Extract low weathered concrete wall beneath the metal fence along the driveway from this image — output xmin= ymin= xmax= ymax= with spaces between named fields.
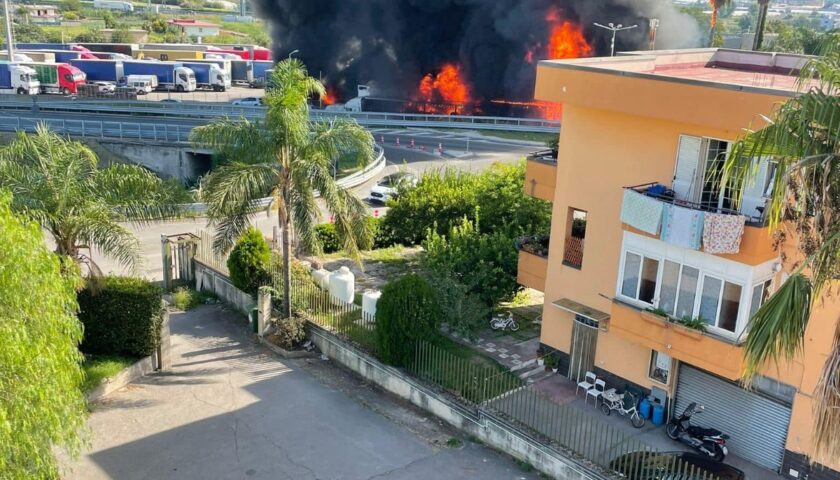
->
xmin=307 ymin=324 xmax=609 ymax=480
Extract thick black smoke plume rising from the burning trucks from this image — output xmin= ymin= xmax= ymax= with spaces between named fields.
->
xmin=251 ymin=0 xmax=701 ymax=101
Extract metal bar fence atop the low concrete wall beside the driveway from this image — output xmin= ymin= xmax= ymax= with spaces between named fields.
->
xmin=284 ymin=274 xmax=717 ymax=480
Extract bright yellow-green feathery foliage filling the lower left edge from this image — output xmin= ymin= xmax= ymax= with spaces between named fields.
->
xmin=0 ymin=191 xmax=87 ymax=479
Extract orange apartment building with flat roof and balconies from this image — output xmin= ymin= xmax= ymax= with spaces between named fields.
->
xmin=519 ymin=49 xmax=840 ymax=479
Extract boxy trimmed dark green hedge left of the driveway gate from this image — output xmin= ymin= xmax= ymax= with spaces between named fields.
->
xmin=78 ymin=277 xmax=163 ymax=357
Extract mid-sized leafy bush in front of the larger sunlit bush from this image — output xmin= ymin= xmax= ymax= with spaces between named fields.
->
xmin=423 ymin=218 xmax=519 ymax=307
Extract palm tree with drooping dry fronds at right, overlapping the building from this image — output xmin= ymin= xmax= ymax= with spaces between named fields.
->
xmin=724 ymin=32 xmax=840 ymax=460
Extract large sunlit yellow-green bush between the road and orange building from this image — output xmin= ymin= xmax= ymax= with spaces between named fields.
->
xmin=380 ymin=161 xmax=551 ymax=246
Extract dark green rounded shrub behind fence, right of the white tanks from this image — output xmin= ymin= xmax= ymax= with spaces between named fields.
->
xmin=376 ymin=274 xmax=442 ymax=366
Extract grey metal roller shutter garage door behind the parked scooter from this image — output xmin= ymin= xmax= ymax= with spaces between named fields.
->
xmin=674 ymin=364 xmax=790 ymax=471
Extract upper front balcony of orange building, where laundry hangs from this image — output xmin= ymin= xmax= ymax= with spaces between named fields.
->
xmin=622 ymin=182 xmax=779 ymax=265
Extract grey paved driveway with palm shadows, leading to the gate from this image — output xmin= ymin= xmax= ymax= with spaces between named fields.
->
xmin=64 ymin=306 xmax=537 ymax=480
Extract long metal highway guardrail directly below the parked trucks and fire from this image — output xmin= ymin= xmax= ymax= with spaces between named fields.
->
xmin=0 ymin=98 xmax=560 ymax=133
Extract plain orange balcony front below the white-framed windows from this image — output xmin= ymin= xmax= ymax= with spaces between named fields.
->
xmin=609 ymin=300 xmax=743 ymax=380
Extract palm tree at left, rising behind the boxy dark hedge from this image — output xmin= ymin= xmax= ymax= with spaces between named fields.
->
xmin=0 ymin=125 xmax=185 ymax=274
